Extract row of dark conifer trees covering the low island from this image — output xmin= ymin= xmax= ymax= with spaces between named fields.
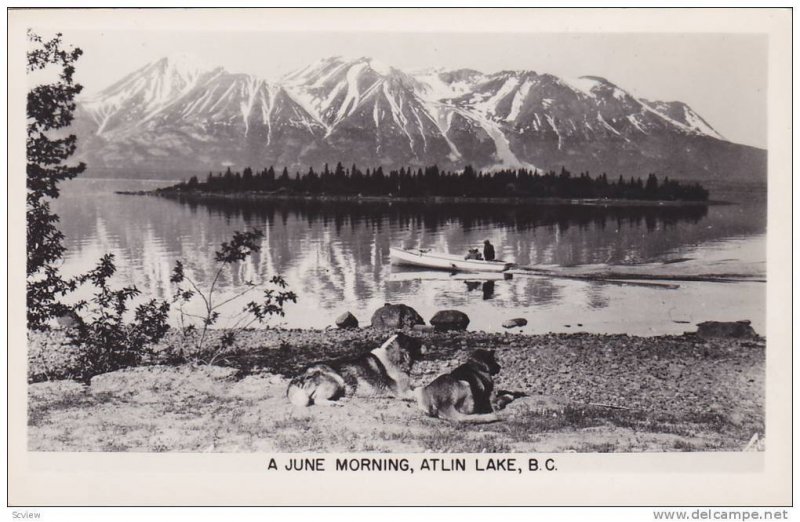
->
xmin=167 ymin=163 xmax=708 ymax=201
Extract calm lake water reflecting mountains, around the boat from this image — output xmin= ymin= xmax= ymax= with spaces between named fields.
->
xmin=54 ymin=179 xmax=766 ymax=335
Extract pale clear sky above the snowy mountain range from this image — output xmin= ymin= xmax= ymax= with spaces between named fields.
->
xmin=64 ymin=30 xmax=768 ymax=148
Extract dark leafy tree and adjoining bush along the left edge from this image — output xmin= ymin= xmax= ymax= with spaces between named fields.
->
xmin=26 ymin=31 xmax=169 ymax=380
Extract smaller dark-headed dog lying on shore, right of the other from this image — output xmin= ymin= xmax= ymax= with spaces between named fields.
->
xmin=414 ymin=350 xmax=500 ymax=423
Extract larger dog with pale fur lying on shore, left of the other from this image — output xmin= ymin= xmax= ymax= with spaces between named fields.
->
xmin=286 ymin=333 xmax=426 ymax=406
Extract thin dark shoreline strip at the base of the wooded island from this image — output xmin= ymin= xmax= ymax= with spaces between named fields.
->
xmin=114 ymin=189 xmax=720 ymax=207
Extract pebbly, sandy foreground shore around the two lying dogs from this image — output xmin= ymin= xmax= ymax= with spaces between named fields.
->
xmin=28 ymin=328 xmax=765 ymax=452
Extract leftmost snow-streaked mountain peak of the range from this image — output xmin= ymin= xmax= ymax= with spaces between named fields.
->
xmin=79 ymin=52 xmax=325 ymax=170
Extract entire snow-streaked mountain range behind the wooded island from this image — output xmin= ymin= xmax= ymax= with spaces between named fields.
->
xmin=75 ymin=52 xmax=766 ymax=179
